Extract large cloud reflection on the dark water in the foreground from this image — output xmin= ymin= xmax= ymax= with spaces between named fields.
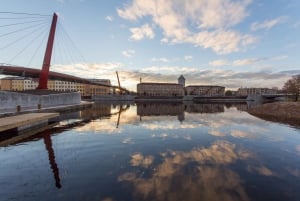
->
xmin=118 ymin=141 xmax=252 ymax=201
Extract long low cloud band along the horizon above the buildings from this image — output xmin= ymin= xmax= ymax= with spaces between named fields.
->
xmin=51 ymin=62 xmax=300 ymax=91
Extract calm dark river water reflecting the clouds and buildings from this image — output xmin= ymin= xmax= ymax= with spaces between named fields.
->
xmin=0 ymin=104 xmax=300 ymax=201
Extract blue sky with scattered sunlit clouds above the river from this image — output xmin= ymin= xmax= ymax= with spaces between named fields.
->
xmin=0 ymin=0 xmax=300 ymax=90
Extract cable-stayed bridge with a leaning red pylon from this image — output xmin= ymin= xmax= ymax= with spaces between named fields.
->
xmin=0 ymin=12 xmax=129 ymax=92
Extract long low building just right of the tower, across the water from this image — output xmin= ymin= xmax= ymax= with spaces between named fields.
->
xmin=185 ymin=85 xmax=225 ymax=96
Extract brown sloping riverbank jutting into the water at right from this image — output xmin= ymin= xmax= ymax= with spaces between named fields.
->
xmin=248 ymin=102 xmax=300 ymax=127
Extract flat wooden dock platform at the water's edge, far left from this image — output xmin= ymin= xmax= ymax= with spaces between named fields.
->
xmin=0 ymin=113 xmax=59 ymax=132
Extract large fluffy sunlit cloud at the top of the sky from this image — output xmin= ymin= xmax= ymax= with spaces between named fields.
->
xmin=117 ymin=0 xmax=257 ymax=54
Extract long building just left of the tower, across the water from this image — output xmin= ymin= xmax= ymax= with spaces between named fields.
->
xmin=137 ymin=82 xmax=184 ymax=97
